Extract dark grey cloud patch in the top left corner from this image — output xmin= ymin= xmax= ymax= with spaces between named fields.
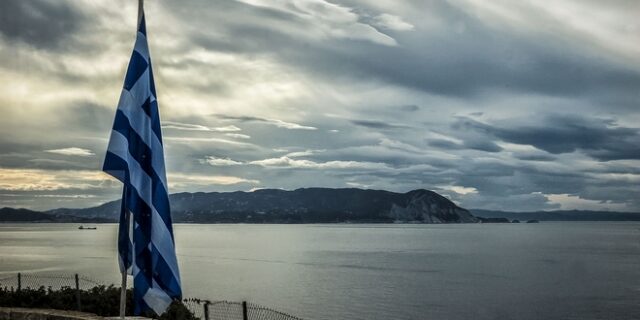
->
xmin=0 ymin=0 xmax=85 ymax=49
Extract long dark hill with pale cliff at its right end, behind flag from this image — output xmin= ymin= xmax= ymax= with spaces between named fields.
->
xmin=48 ymin=188 xmax=478 ymax=223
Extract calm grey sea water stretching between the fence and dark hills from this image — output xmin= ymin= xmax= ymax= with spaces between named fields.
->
xmin=0 ymin=223 xmax=640 ymax=320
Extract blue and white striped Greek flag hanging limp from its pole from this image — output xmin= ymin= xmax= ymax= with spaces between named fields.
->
xmin=102 ymin=15 xmax=182 ymax=315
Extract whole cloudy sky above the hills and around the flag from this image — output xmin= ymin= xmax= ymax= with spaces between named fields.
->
xmin=0 ymin=0 xmax=640 ymax=211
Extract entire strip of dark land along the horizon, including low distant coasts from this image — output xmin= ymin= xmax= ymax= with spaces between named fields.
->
xmin=0 ymin=188 xmax=640 ymax=223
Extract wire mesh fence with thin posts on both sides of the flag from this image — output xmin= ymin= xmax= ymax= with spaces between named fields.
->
xmin=0 ymin=273 xmax=302 ymax=320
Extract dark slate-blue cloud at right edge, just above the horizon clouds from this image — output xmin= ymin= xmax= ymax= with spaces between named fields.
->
xmin=453 ymin=114 xmax=640 ymax=161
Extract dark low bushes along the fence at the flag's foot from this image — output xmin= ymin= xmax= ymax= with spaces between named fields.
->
xmin=0 ymin=285 xmax=198 ymax=320
